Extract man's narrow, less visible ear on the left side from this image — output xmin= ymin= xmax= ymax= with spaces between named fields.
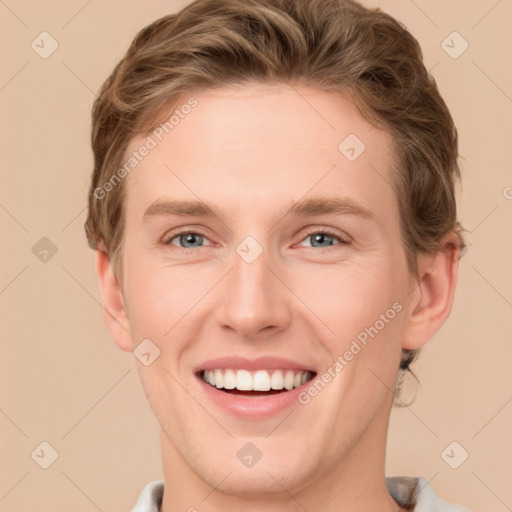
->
xmin=96 ymin=250 xmax=133 ymax=352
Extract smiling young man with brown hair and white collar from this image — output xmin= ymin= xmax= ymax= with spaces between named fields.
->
xmin=86 ymin=0 xmax=464 ymax=512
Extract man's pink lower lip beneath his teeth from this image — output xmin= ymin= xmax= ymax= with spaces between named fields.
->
xmin=197 ymin=377 xmax=311 ymax=419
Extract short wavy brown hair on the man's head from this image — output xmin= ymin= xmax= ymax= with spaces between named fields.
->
xmin=85 ymin=0 xmax=465 ymax=384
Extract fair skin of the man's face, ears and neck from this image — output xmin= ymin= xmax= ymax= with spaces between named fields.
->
xmin=97 ymin=84 xmax=458 ymax=512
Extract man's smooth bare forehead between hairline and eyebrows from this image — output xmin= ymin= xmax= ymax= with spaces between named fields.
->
xmin=122 ymin=84 xmax=396 ymax=224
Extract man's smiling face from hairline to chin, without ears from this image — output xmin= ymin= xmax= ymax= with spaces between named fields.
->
xmin=119 ymin=85 xmax=411 ymax=493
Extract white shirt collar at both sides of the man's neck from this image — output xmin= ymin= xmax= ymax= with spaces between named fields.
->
xmin=131 ymin=476 xmax=469 ymax=512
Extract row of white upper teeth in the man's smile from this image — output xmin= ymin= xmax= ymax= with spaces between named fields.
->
xmin=203 ymin=369 xmax=312 ymax=391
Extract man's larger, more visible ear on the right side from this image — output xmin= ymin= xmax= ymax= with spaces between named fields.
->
xmin=402 ymin=233 xmax=459 ymax=350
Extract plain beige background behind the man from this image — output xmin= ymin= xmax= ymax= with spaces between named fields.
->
xmin=0 ymin=0 xmax=512 ymax=512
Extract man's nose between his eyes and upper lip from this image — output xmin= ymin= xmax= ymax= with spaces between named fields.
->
xmin=216 ymin=243 xmax=293 ymax=341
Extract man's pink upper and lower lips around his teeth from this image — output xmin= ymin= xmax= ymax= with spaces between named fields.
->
xmin=194 ymin=356 xmax=317 ymax=420
